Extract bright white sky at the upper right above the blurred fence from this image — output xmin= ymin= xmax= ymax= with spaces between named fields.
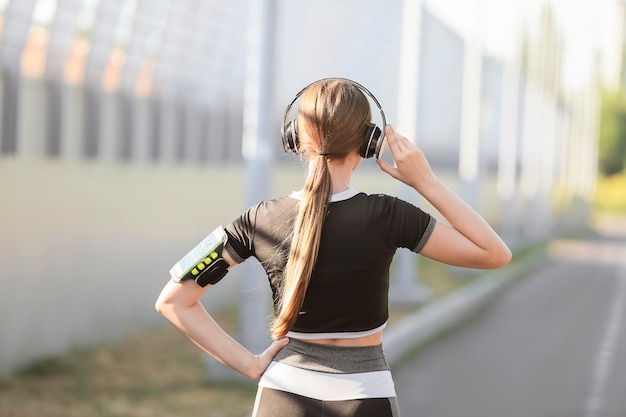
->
xmin=423 ymin=0 xmax=624 ymax=88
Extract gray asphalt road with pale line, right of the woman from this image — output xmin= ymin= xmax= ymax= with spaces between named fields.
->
xmin=393 ymin=216 xmax=626 ymax=417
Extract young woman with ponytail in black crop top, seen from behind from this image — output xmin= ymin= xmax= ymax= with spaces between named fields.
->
xmin=156 ymin=79 xmax=511 ymax=417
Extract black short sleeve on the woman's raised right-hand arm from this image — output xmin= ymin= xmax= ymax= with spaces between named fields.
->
xmin=389 ymin=197 xmax=437 ymax=252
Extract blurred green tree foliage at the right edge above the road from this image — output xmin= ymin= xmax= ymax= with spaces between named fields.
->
xmin=598 ymin=91 xmax=626 ymax=176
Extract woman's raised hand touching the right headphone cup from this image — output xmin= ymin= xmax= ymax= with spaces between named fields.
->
xmin=376 ymin=125 xmax=436 ymax=192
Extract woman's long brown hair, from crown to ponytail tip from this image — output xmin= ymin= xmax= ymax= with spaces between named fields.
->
xmin=270 ymin=79 xmax=371 ymax=339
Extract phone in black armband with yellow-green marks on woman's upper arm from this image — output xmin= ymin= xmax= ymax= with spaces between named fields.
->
xmin=170 ymin=226 xmax=229 ymax=287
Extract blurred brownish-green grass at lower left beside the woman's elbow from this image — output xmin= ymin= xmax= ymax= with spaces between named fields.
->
xmin=0 ymin=308 xmax=256 ymax=417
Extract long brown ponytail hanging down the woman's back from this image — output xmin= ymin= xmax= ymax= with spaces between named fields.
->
xmin=270 ymin=156 xmax=332 ymax=340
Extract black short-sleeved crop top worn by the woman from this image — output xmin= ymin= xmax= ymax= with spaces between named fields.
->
xmin=225 ymin=189 xmax=435 ymax=333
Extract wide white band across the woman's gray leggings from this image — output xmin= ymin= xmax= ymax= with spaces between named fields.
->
xmin=259 ymin=362 xmax=396 ymax=401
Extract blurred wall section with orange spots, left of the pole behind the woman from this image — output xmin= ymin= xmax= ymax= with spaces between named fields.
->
xmin=0 ymin=0 xmax=252 ymax=161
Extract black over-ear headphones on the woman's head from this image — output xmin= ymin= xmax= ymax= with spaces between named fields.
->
xmin=281 ymin=77 xmax=387 ymax=159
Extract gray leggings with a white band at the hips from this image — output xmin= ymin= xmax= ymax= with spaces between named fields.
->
xmin=252 ymin=339 xmax=400 ymax=417
